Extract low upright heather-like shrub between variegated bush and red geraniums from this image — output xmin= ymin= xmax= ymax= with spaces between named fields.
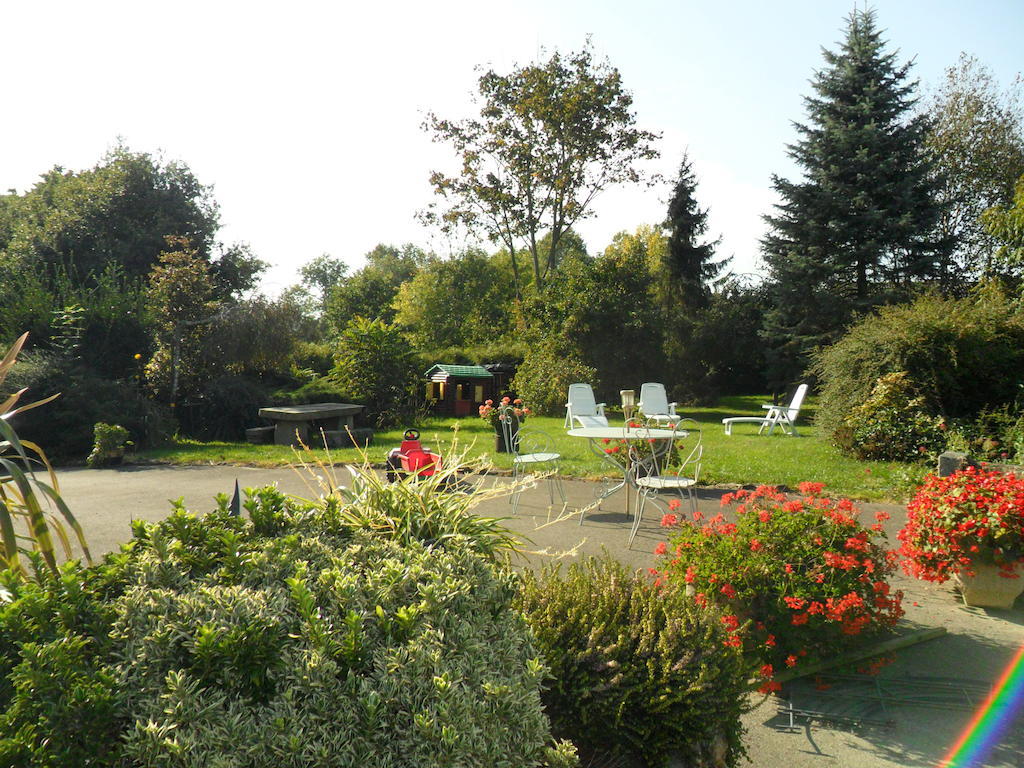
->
xmin=520 ymin=553 xmax=748 ymax=766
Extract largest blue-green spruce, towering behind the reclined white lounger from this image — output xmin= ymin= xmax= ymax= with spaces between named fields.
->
xmin=762 ymin=10 xmax=948 ymax=386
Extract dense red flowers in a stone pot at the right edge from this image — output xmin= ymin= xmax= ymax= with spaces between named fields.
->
xmin=899 ymin=467 xmax=1024 ymax=608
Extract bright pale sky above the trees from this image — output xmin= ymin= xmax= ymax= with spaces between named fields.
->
xmin=0 ymin=0 xmax=1024 ymax=295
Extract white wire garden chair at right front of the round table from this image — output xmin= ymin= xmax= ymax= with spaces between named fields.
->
xmin=629 ymin=419 xmax=703 ymax=547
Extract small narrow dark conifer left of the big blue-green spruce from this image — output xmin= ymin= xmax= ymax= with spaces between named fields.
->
xmin=665 ymin=155 xmax=729 ymax=311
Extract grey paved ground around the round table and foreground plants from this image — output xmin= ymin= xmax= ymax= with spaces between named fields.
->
xmin=59 ymin=466 xmax=1024 ymax=768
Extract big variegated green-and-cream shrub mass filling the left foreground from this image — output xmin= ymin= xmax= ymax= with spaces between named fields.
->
xmin=0 ymin=481 xmax=573 ymax=768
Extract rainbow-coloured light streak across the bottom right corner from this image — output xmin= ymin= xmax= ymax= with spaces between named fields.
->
xmin=938 ymin=645 xmax=1024 ymax=768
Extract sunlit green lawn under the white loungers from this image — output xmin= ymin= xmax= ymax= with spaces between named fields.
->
xmin=139 ymin=396 xmax=930 ymax=502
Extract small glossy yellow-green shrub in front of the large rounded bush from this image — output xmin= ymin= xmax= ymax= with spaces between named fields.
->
xmin=843 ymin=371 xmax=946 ymax=462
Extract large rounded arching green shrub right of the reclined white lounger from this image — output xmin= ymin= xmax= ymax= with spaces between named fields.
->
xmin=813 ymin=287 xmax=1024 ymax=444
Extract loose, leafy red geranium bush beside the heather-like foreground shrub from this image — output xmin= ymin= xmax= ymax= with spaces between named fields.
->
xmin=653 ymin=482 xmax=903 ymax=692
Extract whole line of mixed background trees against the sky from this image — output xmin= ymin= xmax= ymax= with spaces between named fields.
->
xmin=0 ymin=10 xmax=1024 ymax=456
